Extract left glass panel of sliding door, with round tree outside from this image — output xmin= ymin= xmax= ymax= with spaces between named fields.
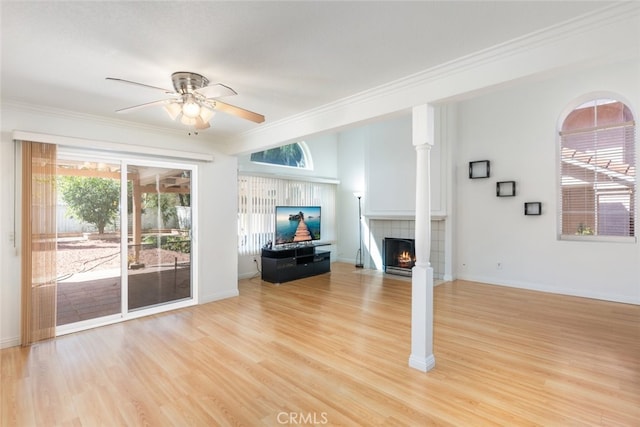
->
xmin=56 ymin=156 xmax=122 ymax=326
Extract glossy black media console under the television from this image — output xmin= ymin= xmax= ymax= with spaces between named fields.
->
xmin=262 ymin=245 xmax=331 ymax=283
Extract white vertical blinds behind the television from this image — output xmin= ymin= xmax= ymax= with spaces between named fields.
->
xmin=238 ymin=175 xmax=336 ymax=255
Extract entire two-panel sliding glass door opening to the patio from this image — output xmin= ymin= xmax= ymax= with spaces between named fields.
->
xmin=56 ymin=150 xmax=195 ymax=334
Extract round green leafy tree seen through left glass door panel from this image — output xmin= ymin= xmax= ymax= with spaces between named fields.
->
xmin=59 ymin=176 xmax=120 ymax=234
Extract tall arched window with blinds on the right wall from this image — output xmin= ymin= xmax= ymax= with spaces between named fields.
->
xmin=560 ymin=99 xmax=636 ymax=239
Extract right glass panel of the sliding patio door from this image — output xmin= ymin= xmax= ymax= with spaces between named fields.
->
xmin=127 ymin=164 xmax=193 ymax=311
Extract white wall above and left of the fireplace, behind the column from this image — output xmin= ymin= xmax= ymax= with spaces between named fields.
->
xmin=337 ymin=110 xmax=450 ymax=270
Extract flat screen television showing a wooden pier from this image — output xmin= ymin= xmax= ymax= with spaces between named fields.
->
xmin=274 ymin=206 xmax=321 ymax=245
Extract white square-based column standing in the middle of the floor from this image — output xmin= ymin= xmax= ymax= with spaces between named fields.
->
xmin=409 ymin=105 xmax=436 ymax=372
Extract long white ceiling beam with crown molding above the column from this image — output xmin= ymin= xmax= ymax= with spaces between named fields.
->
xmin=225 ymin=1 xmax=640 ymax=154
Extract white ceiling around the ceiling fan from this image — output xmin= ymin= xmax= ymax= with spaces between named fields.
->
xmin=0 ymin=1 xmax=616 ymax=144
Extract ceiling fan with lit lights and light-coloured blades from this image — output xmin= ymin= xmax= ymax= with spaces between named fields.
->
xmin=106 ymin=71 xmax=264 ymax=129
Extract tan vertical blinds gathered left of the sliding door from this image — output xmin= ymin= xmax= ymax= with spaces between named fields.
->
xmin=21 ymin=142 xmax=57 ymax=345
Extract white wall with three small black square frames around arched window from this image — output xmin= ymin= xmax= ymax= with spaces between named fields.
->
xmin=454 ymin=59 xmax=640 ymax=304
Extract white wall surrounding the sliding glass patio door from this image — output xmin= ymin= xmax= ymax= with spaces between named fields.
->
xmin=0 ymin=105 xmax=238 ymax=347
